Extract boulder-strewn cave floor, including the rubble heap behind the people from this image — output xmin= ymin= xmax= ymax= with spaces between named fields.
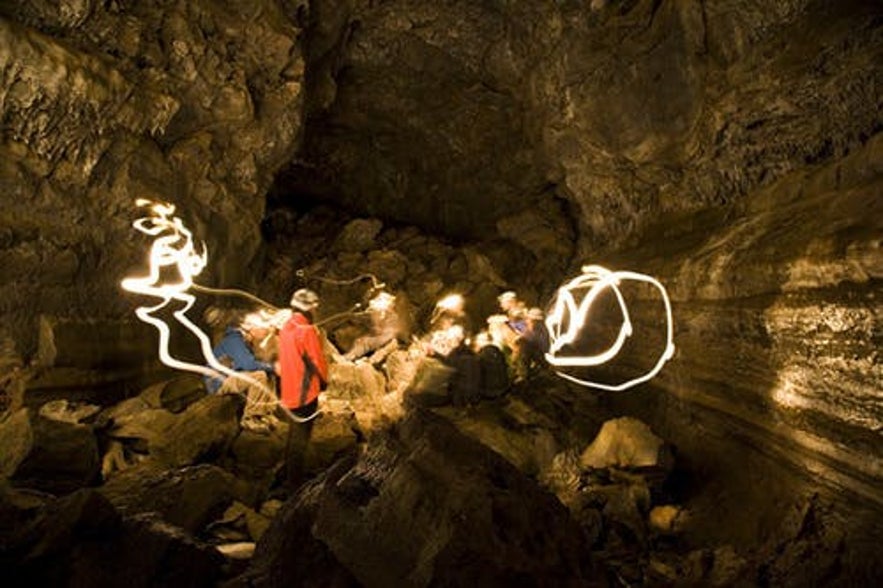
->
xmin=0 ymin=204 xmax=846 ymax=586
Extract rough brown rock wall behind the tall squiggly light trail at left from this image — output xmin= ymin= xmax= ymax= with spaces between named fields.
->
xmin=0 ymin=0 xmax=303 ymax=356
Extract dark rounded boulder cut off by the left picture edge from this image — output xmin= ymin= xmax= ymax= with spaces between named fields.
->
xmin=0 ymin=408 xmax=100 ymax=492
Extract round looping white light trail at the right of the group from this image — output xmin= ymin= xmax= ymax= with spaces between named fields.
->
xmin=546 ymin=265 xmax=675 ymax=391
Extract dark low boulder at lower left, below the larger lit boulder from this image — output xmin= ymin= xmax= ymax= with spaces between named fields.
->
xmin=98 ymin=462 xmax=242 ymax=534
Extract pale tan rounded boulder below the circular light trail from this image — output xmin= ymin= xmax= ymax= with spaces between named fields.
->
xmin=580 ymin=417 xmax=664 ymax=468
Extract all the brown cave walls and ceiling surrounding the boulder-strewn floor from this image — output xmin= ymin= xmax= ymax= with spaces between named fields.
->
xmin=0 ymin=0 xmax=883 ymax=580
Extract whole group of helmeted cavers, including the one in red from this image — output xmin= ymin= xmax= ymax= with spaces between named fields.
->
xmin=199 ymin=288 xmax=549 ymax=479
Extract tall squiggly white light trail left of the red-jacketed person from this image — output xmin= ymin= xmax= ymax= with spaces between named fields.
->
xmin=120 ymin=198 xmax=318 ymax=423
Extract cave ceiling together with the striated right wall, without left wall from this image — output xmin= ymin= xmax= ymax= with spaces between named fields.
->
xmin=287 ymin=0 xmax=883 ymax=552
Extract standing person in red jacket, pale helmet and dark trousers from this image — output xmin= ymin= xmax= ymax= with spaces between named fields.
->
xmin=278 ymin=288 xmax=328 ymax=491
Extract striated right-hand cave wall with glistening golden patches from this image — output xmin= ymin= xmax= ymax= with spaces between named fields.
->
xmin=611 ymin=136 xmax=883 ymax=541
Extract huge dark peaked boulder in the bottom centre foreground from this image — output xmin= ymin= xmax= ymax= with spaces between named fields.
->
xmin=243 ymin=410 xmax=606 ymax=586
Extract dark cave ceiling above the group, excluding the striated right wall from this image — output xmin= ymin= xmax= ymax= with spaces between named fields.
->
xmin=286 ymin=0 xmax=881 ymax=248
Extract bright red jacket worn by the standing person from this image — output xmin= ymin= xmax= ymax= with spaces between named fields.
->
xmin=279 ymin=312 xmax=328 ymax=409
